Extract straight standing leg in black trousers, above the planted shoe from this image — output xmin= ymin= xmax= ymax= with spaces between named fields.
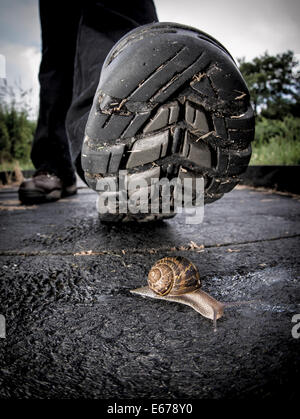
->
xmin=31 ymin=0 xmax=81 ymax=186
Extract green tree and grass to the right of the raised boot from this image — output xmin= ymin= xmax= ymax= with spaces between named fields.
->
xmin=238 ymin=51 xmax=300 ymax=165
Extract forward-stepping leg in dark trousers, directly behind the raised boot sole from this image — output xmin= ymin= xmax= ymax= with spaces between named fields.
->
xmin=66 ymin=0 xmax=158 ymax=178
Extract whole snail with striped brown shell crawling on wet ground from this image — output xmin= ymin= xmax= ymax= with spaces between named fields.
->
xmin=131 ymin=256 xmax=256 ymax=330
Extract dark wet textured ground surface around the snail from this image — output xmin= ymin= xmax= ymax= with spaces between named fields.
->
xmin=0 ymin=187 xmax=300 ymax=400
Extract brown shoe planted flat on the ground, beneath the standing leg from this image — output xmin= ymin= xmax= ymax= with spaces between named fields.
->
xmin=19 ymin=171 xmax=77 ymax=205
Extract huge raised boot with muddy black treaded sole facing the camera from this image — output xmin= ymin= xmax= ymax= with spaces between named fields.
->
xmin=81 ymin=23 xmax=254 ymax=221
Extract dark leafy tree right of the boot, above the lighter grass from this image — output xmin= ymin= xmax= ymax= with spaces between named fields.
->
xmin=238 ymin=51 xmax=300 ymax=119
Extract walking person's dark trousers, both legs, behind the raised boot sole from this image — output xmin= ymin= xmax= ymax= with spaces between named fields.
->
xmin=31 ymin=0 xmax=157 ymax=185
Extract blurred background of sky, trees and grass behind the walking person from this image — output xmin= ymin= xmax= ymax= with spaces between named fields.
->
xmin=0 ymin=0 xmax=300 ymax=176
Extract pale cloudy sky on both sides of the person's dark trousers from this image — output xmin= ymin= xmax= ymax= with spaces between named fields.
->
xmin=0 ymin=0 xmax=300 ymax=118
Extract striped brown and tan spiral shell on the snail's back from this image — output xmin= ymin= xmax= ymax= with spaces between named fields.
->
xmin=148 ymin=256 xmax=201 ymax=296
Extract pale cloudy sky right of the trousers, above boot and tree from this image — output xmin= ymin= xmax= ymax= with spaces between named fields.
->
xmin=155 ymin=0 xmax=300 ymax=60
